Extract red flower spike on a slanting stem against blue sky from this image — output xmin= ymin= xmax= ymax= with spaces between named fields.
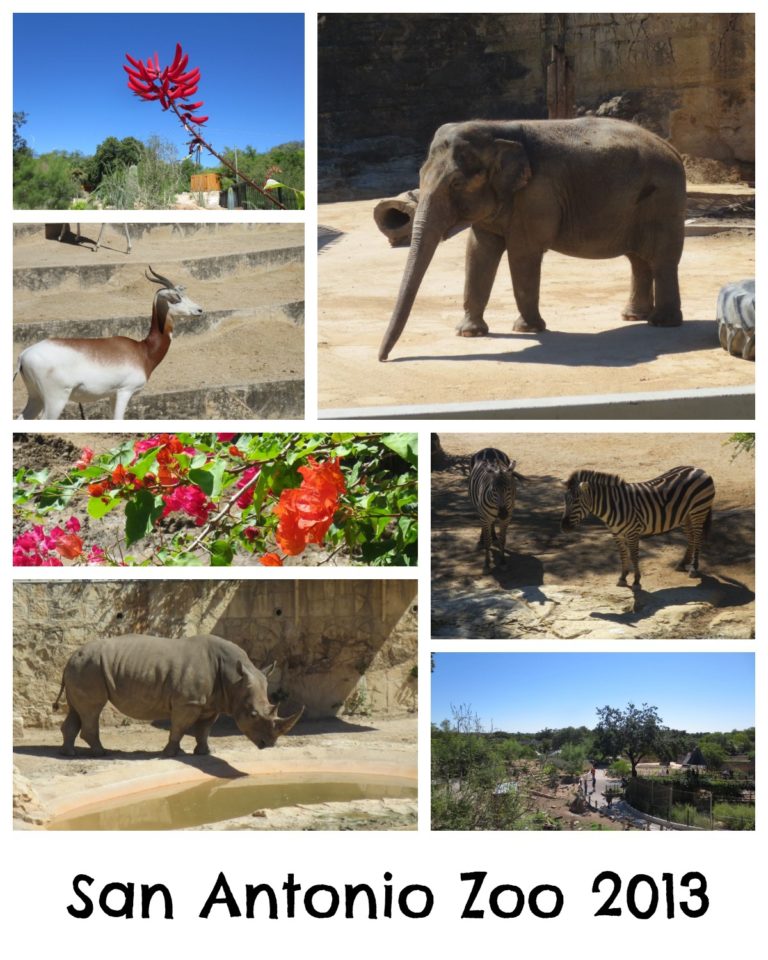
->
xmin=123 ymin=43 xmax=286 ymax=210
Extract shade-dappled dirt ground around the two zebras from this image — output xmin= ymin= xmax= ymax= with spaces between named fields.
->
xmin=432 ymin=433 xmax=755 ymax=639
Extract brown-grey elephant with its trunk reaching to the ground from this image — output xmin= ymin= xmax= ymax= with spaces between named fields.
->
xmin=379 ymin=117 xmax=685 ymax=360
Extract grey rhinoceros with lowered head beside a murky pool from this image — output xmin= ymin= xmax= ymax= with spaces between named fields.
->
xmin=53 ymin=634 xmax=304 ymax=757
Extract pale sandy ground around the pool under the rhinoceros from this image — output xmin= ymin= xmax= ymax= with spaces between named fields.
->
xmin=14 ymin=716 xmax=417 ymax=830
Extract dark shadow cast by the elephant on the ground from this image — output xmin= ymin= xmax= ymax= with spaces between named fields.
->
xmin=387 ymin=320 xmax=719 ymax=368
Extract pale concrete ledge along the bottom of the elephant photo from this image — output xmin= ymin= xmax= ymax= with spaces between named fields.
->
xmin=318 ymin=387 xmax=755 ymax=420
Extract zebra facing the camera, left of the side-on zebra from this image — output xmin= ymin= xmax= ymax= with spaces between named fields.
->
xmin=469 ymin=447 xmax=524 ymax=573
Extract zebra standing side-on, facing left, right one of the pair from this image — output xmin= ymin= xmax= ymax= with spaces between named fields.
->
xmin=560 ymin=467 xmax=715 ymax=587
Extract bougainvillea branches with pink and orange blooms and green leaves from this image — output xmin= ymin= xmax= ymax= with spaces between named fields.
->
xmin=13 ymin=433 xmax=418 ymax=566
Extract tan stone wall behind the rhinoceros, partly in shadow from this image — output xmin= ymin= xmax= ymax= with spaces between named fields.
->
xmin=13 ymin=580 xmax=417 ymax=727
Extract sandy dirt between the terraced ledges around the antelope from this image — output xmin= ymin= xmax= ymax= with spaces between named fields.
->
xmin=13 ymin=224 xmax=304 ymax=418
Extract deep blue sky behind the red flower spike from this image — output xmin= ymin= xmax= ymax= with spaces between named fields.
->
xmin=13 ymin=13 xmax=304 ymax=163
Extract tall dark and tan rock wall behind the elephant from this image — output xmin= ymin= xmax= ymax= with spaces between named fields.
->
xmin=318 ymin=13 xmax=755 ymax=201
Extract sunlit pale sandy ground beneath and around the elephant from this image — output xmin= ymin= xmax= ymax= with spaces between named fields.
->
xmin=318 ymin=193 xmax=755 ymax=411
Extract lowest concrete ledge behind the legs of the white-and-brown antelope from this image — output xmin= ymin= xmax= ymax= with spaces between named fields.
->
xmin=54 ymin=380 xmax=304 ymax=420
